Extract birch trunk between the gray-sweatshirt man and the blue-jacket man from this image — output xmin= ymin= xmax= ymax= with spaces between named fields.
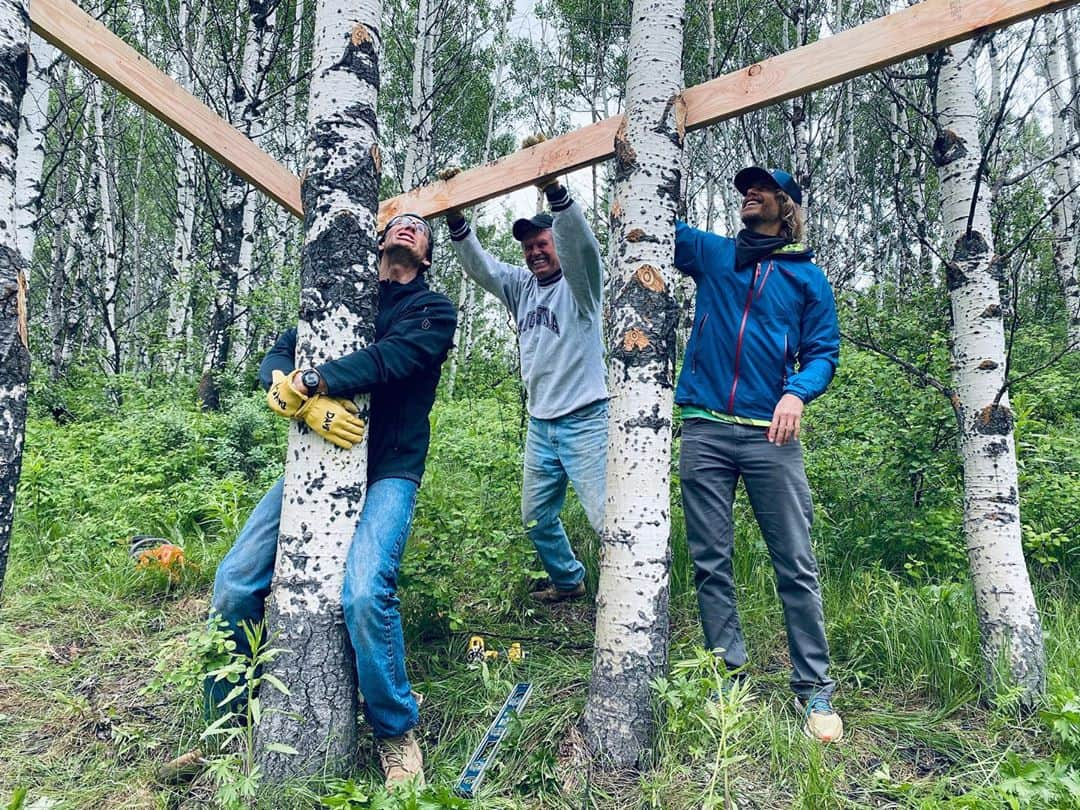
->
xmin=582 ymin=0 xmax=685 ymax=768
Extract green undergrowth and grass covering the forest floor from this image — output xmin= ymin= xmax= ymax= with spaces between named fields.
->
xmin=0 ymin=371 xmax=1080 ymax=810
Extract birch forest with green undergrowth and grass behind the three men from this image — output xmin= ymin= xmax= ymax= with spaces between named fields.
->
xmin=0 ymin=0 xmax=1080 ymax=808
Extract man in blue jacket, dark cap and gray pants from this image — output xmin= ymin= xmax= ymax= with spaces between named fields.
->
xmin=675 ymin=166 xmax=843 ymax=742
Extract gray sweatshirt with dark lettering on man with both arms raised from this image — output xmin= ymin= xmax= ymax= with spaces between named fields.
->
xmin=450 ymin=188 xmax=608 ymax=419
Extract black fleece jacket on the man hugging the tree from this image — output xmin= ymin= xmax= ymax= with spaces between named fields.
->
xmin=259 ymin=273 xmax=457 ymax=484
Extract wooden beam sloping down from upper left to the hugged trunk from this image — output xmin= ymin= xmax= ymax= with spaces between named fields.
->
xmin=30 ymin=0 xmax=303 ymax=217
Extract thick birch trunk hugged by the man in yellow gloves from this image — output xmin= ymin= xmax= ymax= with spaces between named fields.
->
xmin=258 ymin=0 xmax=380 ymax=783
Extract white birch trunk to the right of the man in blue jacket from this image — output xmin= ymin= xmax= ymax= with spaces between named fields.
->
xmin=934 ymin=42 xmax=1045 ymax=703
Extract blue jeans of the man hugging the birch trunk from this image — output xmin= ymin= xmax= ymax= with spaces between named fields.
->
xmin=204 ymin=478 xmax=417 ymax=738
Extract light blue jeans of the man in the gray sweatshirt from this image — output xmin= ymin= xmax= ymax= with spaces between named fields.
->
xmin=522 ymin=401 xmax=608 ymax=591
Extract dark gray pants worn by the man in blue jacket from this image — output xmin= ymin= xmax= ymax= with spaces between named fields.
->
xmin=679 ymin=419 xmax=834 ymax=698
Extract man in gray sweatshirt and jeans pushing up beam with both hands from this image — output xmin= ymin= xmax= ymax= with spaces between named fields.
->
xmin=446 ymin=178 xmax=608 ymax=603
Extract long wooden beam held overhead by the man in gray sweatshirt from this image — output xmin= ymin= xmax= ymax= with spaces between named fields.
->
xmin=379 ymin=0 xmax=1078 ymax=221
